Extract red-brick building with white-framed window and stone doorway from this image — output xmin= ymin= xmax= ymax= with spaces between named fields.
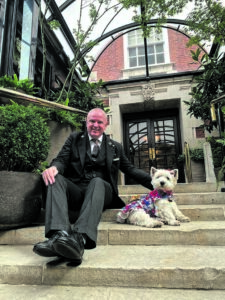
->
xmin=90 ymin=27 xmax=214 ymax=184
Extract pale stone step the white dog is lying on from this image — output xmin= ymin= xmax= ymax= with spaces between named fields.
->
xmin=0 ymin=221 xmax=225 ymax=246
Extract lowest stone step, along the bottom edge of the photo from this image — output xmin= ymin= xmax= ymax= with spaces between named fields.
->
xmin=0 ymin=284 xmax=225 ymax=300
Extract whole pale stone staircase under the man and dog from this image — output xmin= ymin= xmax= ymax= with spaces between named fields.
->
xmin=0 ymin=183 xmax=225 ymax=300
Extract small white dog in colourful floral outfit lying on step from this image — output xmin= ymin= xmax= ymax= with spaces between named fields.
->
xmin=116 ymin=167 xmax=190 ymax=227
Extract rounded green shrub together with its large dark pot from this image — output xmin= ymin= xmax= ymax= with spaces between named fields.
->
xmin=0 ymin=102 xmax=49 ymax=229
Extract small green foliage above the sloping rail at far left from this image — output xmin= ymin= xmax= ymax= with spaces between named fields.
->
xmin=0 ymin=74 xmax=38 ymax=95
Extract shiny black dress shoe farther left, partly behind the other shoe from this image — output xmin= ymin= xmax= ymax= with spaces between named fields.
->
xmin=33 ymin=231 xmax=68 ymax=257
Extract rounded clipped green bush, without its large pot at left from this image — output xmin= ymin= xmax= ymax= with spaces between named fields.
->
xmin=0 ymin=101 xmax=49 ymax=171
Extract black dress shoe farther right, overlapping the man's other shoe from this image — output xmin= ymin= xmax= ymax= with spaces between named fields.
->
xmin=53 ymin=232 xmax=84 ymax=262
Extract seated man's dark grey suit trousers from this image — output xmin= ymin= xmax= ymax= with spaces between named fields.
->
xmin=45 ymin=174 xmax=113 ymax=249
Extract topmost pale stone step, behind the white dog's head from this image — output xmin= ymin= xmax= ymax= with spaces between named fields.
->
xmin=118 ymin=182 xmax=218 ymax=195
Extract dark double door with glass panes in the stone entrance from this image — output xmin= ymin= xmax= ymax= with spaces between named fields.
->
xmin=124 ymin=110 xmax=185 ymax=184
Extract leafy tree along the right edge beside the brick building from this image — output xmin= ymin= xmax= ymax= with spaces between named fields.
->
xmin=182 ymin=1 xmax=225 ymax=132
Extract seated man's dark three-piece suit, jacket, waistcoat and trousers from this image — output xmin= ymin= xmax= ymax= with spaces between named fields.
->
xmin=45 ymin=132 xmax=152 ymax=249
